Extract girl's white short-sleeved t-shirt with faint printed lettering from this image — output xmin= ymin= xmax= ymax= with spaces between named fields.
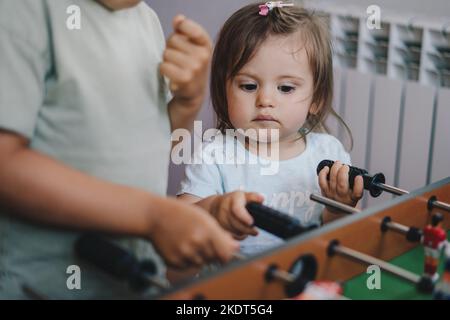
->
xmin=178 ymin=133 xmax=351 ymax=255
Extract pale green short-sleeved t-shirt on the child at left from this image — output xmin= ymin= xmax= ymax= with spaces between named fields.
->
xmin=0 ymin=0 xmax=170 ymax=298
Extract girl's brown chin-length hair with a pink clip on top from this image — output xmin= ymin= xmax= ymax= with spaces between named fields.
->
xmin=210 ymin=3 xmax=353 ymax=149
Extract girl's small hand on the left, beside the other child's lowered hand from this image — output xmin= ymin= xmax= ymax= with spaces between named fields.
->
xmin=211 ymin=191 xmax=264 ymax=240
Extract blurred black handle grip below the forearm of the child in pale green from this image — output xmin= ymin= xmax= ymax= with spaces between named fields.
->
xmin=75 ymin=234 xmax=157 ymax=290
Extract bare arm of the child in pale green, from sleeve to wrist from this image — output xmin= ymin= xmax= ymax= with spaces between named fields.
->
xmin=0 ymin=131 xmax=153 ymax=237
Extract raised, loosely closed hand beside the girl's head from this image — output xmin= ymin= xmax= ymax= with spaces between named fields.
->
xmin=160 ymin=15 xmax=212 ymax=102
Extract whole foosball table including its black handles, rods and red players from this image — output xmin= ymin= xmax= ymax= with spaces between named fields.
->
xmin=76 ymin=160 xmax=450 ymax=300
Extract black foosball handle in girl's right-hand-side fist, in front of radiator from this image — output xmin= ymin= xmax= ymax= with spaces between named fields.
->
xmin=317 ymin=160 xmax=386 ymax=198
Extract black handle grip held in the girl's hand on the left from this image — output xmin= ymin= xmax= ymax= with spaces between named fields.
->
xmin=246 ymin=202 xmax=316 ymax=239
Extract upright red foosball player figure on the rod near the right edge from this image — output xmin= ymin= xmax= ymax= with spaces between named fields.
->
xmin=422 ymin=213 xmax=447 ymax=281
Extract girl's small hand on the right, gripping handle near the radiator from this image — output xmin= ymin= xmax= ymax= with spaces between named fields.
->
xmin=319 ymin=161 xmax=364 ymax=211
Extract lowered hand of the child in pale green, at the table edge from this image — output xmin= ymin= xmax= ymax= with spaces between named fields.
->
xmin=148 ymin=199 xmax=239 ymax=269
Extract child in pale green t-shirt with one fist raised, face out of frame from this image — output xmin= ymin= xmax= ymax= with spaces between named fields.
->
xmin=0 ymin=0 xmax=238 ymax=298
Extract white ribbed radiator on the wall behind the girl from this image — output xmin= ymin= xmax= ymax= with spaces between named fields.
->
xmin=305 ymin=1 xmax=450 ymax=206
